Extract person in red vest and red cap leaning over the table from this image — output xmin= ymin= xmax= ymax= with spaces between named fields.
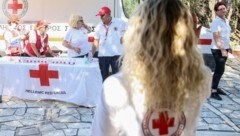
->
xmin=25 ymin=20 xmax=57 ymax=58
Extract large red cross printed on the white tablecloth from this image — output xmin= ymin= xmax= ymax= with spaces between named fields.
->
xmin=29 ymin=64 xmax=58 ymax=86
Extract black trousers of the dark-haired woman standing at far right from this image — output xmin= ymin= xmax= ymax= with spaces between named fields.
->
xmin=211 ymin=49 xmax=229 ymax=89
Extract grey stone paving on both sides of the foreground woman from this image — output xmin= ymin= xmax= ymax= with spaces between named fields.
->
xmin=0 ymin=59 xmax=240 ymax=136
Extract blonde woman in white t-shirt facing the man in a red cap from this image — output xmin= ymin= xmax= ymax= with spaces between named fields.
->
xmin=62 ymin=15 xmax=91 ymax=58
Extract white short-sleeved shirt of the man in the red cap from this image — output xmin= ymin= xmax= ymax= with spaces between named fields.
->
xmin=94 ymin=18 xmax=126 ymax=57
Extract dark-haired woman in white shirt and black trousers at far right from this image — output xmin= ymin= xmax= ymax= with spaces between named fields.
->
xmin=211 ymin=2 xmax=231 ymax=100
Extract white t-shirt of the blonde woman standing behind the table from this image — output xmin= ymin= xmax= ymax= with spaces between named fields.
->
xmin=64 ymin=28 xmax=91 ymax=57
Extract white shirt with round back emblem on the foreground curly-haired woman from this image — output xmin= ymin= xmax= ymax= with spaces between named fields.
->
xmin=92 ymin=71 xmax=211 ymax=136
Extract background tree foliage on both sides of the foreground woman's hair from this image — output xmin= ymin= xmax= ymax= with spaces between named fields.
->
xmin=122 ymin=0 xmax=240 ymax=45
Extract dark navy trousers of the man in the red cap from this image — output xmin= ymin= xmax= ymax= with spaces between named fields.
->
xmin=98 ymin=56 xmax=120 ymax=81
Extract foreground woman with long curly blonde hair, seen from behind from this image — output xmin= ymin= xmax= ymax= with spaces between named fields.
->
xmin=92 ymin=0 xmax=211 ymax=136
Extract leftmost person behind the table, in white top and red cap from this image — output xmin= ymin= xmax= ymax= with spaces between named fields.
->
xmin=3 ymin=15 xmax=25 ymax=56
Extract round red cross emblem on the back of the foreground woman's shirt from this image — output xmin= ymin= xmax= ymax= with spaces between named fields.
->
xmin=142 ymin=108 xmax=186 ymax=136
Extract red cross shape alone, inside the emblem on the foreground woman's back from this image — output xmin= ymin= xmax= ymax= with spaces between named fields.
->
xmin=152 ymin=111 xmax=174 ymax=135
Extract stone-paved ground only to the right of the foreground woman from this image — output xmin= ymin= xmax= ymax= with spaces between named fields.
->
xmin=197 ymin=59 xmax=240 ymax=136
